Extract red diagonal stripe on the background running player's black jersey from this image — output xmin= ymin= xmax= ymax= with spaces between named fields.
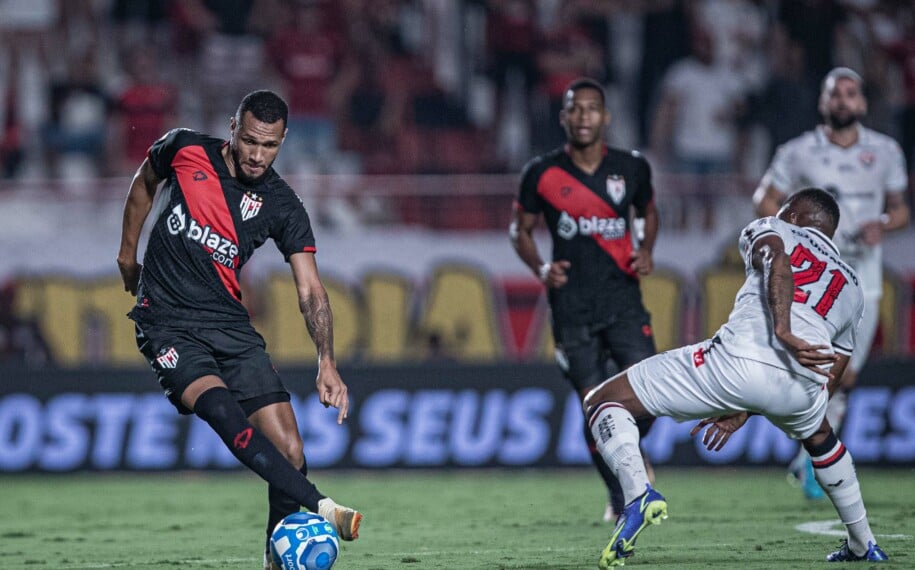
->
xmin=537 ymin=166 xmax=638 ymax=278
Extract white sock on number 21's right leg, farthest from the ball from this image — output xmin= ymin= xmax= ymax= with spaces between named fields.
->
xmin=810 ymin=440 xmax=877 ymax=555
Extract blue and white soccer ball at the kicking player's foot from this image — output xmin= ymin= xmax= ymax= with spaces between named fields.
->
xmin=270 ymin=512 xmax=340 ymax=570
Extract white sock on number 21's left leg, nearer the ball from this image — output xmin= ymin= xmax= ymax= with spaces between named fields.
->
xmin=588 ymin=402 xmax=648 ymax=505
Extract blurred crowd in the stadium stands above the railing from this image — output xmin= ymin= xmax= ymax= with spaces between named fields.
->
xmin=0 ymin=0 xmax=915 ymax=187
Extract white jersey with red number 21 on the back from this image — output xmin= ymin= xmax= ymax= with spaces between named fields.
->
xmin=717 ymin=217 xmax=864 ymax=383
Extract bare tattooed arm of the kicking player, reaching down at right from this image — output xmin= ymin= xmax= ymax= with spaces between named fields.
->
xmin=289 ymin=252 xmax=349 ymax=424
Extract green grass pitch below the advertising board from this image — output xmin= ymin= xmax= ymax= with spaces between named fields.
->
xmin=0 ymin=467 xmax=915 ymax=570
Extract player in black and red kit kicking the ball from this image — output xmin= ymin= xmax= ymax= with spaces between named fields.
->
xmin=117 ymin=91 xmax=362 ymax=568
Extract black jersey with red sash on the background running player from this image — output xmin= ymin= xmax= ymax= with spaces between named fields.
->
xmin=518 ymin=147 xmax=654 ymax=325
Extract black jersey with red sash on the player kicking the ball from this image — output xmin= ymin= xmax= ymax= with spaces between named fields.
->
xmin=129 ymin=129 xmax=315 ymax=328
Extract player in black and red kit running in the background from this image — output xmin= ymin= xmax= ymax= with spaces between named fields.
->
xmin=509 ymin=78 xmax=658 ymax=522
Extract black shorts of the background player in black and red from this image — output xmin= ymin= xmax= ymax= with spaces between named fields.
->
xmin=553 ymin=307 xmax=657 ymax=393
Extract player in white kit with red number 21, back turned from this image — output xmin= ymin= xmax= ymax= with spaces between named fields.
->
xmin=584 ymin=188 xmax=887 ymax=568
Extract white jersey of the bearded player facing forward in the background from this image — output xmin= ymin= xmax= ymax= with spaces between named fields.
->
xmin=764 ymin=125 xmax=908 ymax=296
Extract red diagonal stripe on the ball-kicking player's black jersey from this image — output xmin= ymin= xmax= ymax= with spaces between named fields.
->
xmin=172 ymin=146 xmax=241 ymax=301
